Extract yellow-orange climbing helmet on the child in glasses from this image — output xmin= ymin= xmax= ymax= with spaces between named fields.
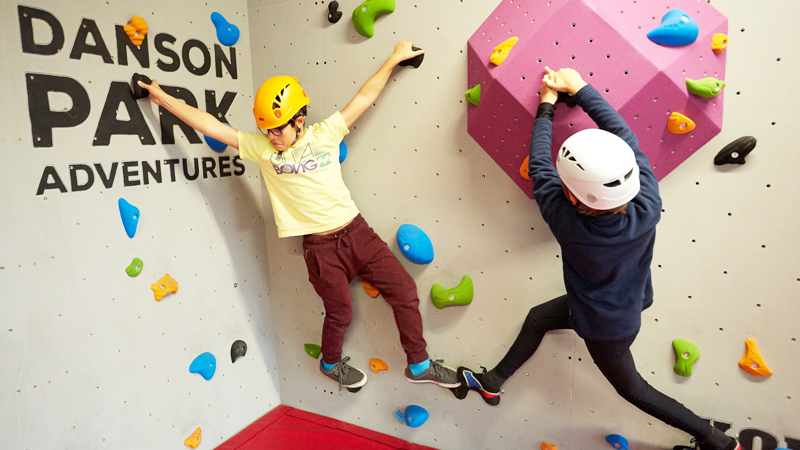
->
xmin=253 ymin=75 xmax=309 ymax=130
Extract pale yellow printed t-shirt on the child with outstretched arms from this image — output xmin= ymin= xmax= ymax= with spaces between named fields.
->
xmin=239 ymin=111 xmax=358 ymax=237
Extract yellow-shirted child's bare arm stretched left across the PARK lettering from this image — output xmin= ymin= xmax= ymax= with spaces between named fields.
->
xmin=138 ymin=80 xmax=239 ymax=150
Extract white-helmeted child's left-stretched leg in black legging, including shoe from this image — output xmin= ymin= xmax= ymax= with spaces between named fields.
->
xmin=458 ymin=295 xmax=570 ymax=406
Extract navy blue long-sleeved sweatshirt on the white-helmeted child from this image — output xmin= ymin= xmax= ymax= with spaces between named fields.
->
xmin=529 ymin=85 xmax=661 ymax=340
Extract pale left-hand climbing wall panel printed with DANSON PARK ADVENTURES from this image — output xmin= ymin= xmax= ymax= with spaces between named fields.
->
xmin=0 ymin=0 xmax=280 ymax=450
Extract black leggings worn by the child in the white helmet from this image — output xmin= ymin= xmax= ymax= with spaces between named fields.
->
xmin=494 ymin=296 xmax=716 ymax=442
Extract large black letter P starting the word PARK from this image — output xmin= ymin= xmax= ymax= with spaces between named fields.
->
xmin=25 ymin=72 xmax=90 ymax=147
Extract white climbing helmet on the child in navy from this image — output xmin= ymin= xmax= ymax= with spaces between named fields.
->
xmin=556 ymin=128 xmax=639 ymax=210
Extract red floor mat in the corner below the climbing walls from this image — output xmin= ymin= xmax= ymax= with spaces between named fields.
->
xmin=217 ymin=405 xmax=435 ymax=450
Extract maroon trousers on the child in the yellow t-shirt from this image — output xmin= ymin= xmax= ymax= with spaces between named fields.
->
xmin=303 ymin=214 xmax=428 ymax=364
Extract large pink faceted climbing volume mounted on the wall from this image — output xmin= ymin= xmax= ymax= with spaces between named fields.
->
xmin=467 ymin=0 xmax=735 ymax=197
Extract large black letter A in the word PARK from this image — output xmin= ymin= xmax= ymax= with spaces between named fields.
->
xmin=92 ymin=81 xmax=156 ymax=146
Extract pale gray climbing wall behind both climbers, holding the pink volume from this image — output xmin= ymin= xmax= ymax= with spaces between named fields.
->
xmin=248 ymin=0 xmax=800 ymax=450
